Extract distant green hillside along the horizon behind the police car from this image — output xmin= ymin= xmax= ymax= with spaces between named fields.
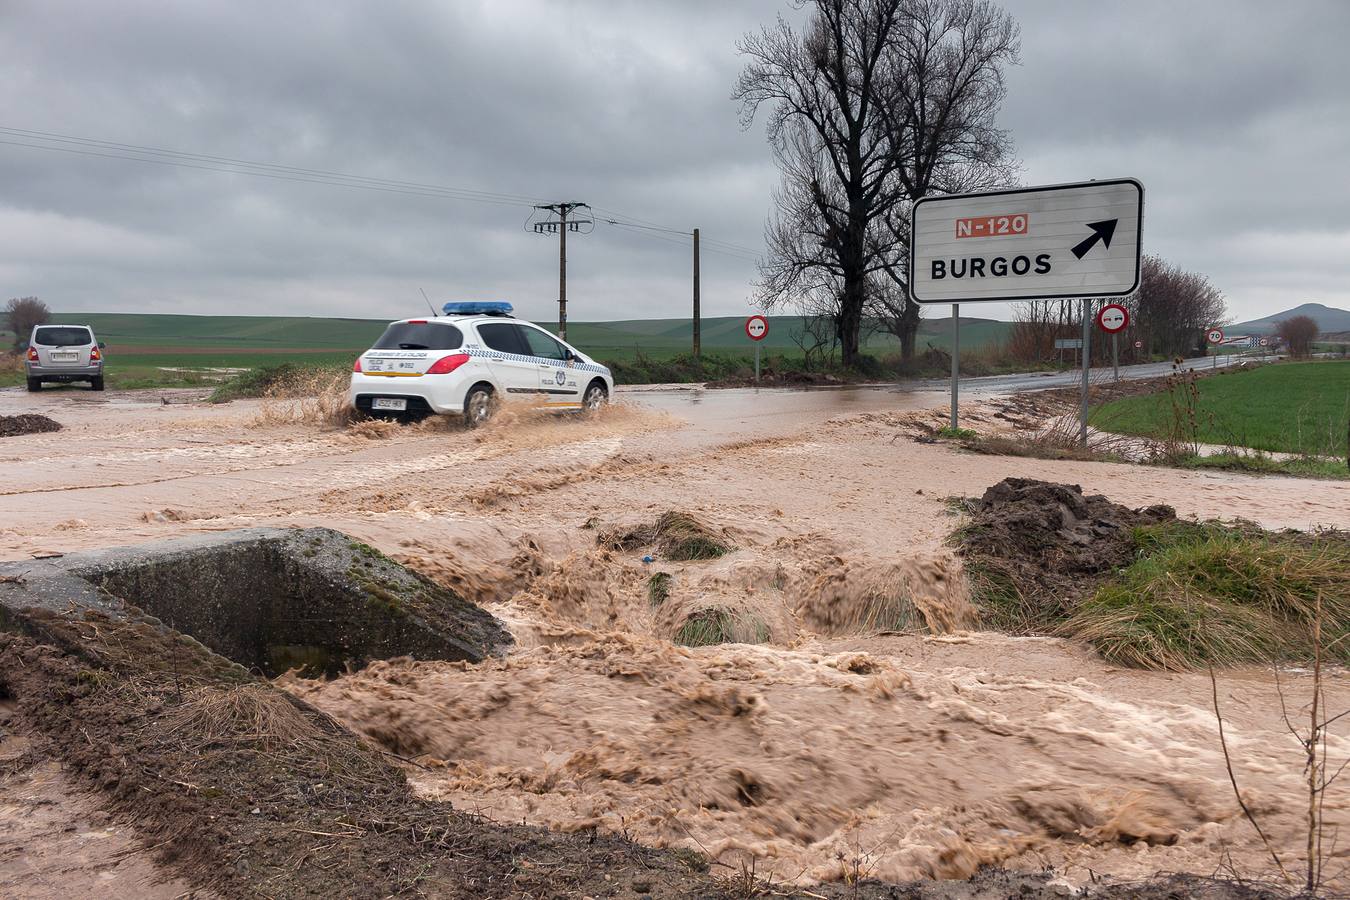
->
xmin=34 ymin=313 xmax=1010 ymax=358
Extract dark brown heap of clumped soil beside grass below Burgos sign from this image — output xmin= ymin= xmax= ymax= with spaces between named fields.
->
xmin=956 ymin=478 xmax=1176 ymax=631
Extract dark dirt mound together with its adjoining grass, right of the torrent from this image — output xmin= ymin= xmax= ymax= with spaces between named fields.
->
xmin=953 ymin=479 xmax=1350 ymax=671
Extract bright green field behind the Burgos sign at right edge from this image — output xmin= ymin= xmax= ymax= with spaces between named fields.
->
xmin=1092 ymin=360 xmax=1350 ymax=459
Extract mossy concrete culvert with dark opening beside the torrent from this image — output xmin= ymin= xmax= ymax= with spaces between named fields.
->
xmin=0 ymin=529 xmax=512 ymax=676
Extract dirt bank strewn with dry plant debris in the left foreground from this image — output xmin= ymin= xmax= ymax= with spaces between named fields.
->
xmin=0 ymin=619 xmax=739 ymax=897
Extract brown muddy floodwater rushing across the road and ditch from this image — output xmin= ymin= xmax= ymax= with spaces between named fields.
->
xmin=0 ymin=389 xmax=1350 ymax=884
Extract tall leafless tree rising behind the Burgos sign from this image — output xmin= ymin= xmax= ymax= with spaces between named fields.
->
xmin=732 ymin=0 xmax=1018 ymax=366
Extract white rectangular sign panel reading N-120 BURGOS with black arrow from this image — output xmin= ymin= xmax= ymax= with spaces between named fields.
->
xmin=910 ymin=178 xmax=1143 ymax=304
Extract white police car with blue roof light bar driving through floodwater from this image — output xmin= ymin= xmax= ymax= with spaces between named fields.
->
xmin=351 ymin=302 xmax=614 ymax=426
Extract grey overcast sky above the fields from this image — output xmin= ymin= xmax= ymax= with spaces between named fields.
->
xmin=0 ymin=0 xmax=1350 ymax=320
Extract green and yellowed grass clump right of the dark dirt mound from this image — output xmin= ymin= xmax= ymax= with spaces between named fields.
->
xmin=1060 ymin=522 xmax=1350 ymax=669
